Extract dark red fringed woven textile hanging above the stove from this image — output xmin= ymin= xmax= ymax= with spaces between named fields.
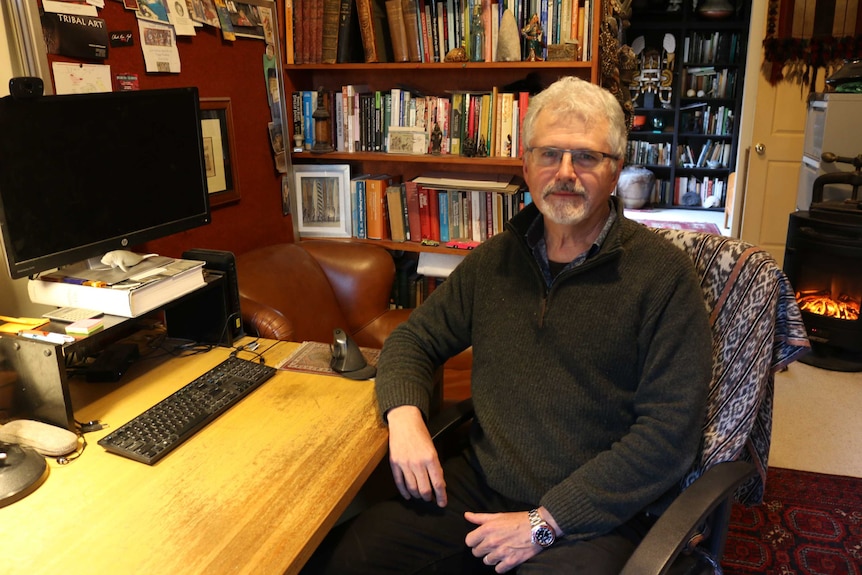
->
xmin=762 ymin=0 xmax=862 ymax=91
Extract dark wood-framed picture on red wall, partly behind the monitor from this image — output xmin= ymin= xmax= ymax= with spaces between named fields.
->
xmin=201 ymin=98 xmax=239 ymax=206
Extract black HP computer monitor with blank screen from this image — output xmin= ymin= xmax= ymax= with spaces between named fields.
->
xmin=0 ymin=87 xmax=210 ymax=279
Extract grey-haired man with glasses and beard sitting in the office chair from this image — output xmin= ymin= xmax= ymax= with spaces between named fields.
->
xmin=309 ymin=78 xmax=712 ymax=575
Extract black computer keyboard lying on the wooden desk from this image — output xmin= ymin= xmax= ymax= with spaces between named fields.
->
xmin=99 ymin=357 xmax=277 ymax=465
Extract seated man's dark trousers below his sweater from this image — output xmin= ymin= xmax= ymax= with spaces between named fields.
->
xmin=303 ymin=454 xmax=652 ymax=575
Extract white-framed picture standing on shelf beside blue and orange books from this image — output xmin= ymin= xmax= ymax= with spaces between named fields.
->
xmin=293 ymin=164 xmax=351 ymax=238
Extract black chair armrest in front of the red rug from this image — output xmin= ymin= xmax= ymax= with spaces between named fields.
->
xmin=620 ymin=461 xmax=755 ymax=575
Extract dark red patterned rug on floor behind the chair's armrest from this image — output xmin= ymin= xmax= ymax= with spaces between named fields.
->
xmin=722 ymin=468 xmax=862 ymax=575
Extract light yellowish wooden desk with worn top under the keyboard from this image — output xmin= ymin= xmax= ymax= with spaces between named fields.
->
xmin=0 ymin=340 xmax=387 ymax=575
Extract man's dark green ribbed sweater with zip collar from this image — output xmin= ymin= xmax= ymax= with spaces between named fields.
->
xmin=376 ymin=198 xmax=712 ymax=538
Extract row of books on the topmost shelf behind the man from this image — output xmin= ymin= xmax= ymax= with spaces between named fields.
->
xmin=285 ymin=0 xmax=594 ymax=64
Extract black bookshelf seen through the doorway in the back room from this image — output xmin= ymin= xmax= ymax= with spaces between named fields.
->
xmin=626 ymin=0 xmax=751 ymax=211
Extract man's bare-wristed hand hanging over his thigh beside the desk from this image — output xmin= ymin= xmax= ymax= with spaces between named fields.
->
xmin=386 ymin=405 xmax=447 ymax=507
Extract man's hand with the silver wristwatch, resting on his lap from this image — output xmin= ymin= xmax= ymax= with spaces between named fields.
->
xmin=464 ymin=507 xmax=561 ymax=573
